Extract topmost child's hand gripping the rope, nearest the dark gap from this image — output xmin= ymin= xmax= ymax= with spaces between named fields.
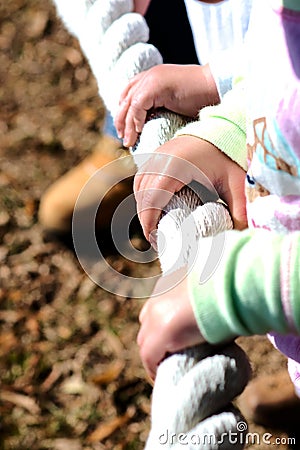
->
xmin=115 ymin=64 xmax=219 ymax=147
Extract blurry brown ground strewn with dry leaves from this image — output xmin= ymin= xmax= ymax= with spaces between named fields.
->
xmin=0 ymin=0 xmax=300 ymax=450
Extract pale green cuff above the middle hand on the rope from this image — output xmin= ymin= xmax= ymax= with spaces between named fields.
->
xmin=175 ymin=82 xmax=247 ymax=170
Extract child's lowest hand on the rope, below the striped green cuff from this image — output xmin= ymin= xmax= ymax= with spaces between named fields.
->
xmin=137 ymin=269 xmax=205 ymax=380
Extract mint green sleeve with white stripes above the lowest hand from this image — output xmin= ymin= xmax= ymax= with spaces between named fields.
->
xmin=189 ymin=229 xmax=300 ymax=343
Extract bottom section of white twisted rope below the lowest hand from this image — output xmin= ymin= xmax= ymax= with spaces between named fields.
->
xmin=146 ymin=344 xmax=249 ymax=450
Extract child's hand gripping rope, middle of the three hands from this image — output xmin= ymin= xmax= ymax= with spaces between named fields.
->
xmin=134 ymin=136 xmax=247 ymax=240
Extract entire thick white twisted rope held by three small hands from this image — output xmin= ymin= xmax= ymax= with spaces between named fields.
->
xmin=54 ymin=0 xmax=250 ymax=450
